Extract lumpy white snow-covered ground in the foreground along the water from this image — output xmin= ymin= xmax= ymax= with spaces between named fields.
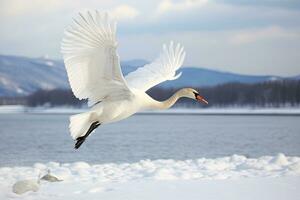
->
xmin=0 ymin=154 xmax=300 ymax=200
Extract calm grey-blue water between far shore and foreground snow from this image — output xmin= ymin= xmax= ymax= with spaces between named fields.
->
xmin=0 ymin=114 xmax=300 ymax=166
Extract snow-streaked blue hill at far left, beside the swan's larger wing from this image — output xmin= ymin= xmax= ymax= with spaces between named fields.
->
xmin=0 ymin=55 xmax=69 ymax=96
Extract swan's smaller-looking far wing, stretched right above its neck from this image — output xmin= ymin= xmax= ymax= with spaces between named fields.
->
xmin=125 ymin=42 xmax=185 ymax=91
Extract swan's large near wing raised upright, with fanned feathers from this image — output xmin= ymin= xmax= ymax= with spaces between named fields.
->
xmin=61 ymin=11 xmax=131 ymax=105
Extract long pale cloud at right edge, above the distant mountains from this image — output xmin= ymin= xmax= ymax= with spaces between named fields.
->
xmin=229 ymin=26 xmax=300 ymax=45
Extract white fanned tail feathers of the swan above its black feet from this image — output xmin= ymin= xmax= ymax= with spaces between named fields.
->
xmin=69 ymin=112 xmax=92 ymax=140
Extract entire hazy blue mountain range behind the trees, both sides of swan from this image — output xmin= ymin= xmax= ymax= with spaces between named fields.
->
xmin=0 ymin=55 xmax=300 ymax=96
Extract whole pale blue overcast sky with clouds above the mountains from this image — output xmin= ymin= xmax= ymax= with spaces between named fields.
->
xmin=0 ymin=0 xmax=300 ymax=76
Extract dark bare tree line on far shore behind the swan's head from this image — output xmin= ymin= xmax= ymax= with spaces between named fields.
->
xmin=0 ymin=80 xmax=300 ymax=107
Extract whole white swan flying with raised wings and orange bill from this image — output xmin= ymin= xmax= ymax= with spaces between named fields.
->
xmin=61 ymin=11 xmax=207 ymax=149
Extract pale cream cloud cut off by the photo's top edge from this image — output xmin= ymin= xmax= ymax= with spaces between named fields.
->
xmin=157 ymin=0 xmax=208 ymax=13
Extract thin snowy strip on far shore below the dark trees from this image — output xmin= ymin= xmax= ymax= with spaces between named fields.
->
xmin=0 ymin=105 xmax=300 ymax=115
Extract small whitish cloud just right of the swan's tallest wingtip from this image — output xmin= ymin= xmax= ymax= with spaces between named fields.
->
xmin=109 ymin=4 xmax=140 ymax=20
